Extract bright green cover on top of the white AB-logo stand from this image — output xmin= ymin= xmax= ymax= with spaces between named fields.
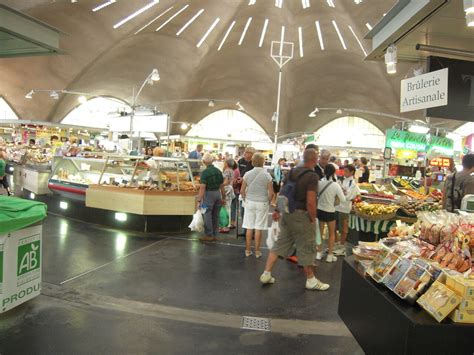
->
xmin=0 ymin=196 xmax=47 ymax=235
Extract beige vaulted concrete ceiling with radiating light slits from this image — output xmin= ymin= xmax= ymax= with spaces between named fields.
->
xmin=0 ymin=0 xmax=432 ymax=134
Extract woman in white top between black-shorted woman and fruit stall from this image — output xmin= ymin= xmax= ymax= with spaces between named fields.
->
xmin=334 ymin=164 xmax=359 ymax=256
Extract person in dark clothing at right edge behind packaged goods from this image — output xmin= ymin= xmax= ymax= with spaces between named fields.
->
xmin=443 ymin=154 xmax=474 ymax=212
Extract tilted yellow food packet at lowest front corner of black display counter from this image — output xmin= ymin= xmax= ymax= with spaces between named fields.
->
xmin=417 ymin=281 xmax=462 ymax=322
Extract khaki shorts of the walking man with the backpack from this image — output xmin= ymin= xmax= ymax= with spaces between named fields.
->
xmin=272 ymin=211 xmax=316 ymax=266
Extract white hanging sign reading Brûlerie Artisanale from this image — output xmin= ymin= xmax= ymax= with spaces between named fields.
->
xmin=400 ymin=68 xmax=448 ymax=112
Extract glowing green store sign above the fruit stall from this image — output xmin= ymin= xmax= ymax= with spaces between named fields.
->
xmin=385 ymin=129 xmax=454 ymax=156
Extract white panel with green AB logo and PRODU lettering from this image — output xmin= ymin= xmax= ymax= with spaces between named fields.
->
xmin=0 ymin=226 xmax=42 ymax=313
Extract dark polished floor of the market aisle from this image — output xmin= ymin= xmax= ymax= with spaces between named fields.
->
xmin=0 ymin=216 xmax=363 ymax=355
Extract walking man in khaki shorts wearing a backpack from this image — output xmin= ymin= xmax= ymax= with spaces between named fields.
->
xmin=260 ymin=149 xmax=329 ymax=291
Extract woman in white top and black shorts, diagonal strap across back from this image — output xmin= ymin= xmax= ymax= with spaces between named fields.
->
xmin=318 ymin=164 xmax=346 ymax=263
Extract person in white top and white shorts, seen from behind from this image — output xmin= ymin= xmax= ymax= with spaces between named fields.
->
xmin=240 ymin=153 xmax=273 ymax=258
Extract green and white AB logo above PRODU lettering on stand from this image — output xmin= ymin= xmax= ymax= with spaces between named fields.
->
xmin=17 ymin=235 xmax=41 ymax=286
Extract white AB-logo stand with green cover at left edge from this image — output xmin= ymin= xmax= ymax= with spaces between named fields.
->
xmin=0 ymin=196 xmax=47 ymax=313
